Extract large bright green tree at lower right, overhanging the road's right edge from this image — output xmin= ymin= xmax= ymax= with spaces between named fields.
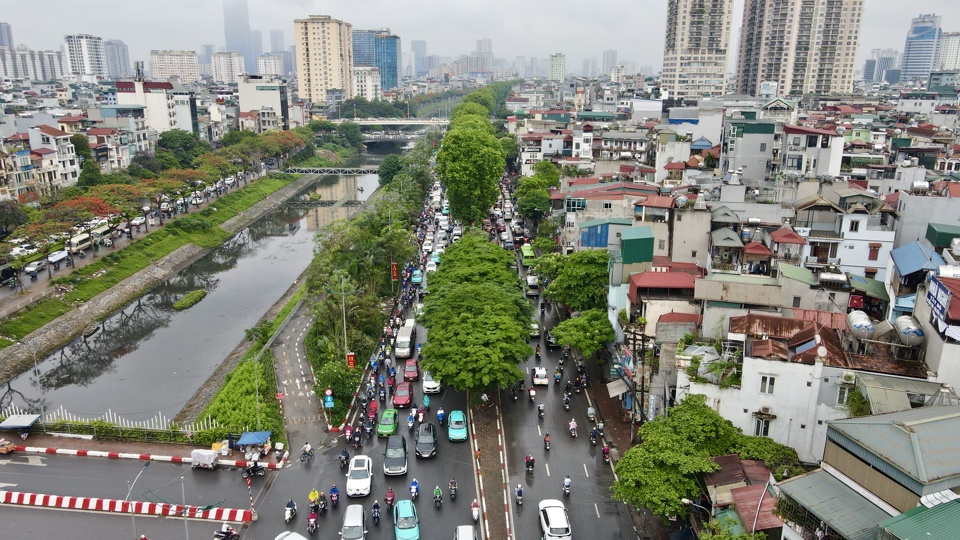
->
xmin=613 ymin=394 xmax=740 ymax=520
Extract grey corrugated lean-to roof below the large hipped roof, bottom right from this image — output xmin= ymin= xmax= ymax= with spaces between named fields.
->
xmin=779 ymin=469 xmax=890 ymax=540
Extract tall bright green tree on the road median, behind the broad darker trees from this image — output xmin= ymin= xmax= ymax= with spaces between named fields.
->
xmin=437 ymin=129 xmax=503 ymax=224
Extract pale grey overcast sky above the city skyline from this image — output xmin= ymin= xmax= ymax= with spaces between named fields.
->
xmin=0 ymin=0 xmax=960 ymax=71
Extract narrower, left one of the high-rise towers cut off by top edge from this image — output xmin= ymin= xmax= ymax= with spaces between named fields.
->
xmin=661 ymin=0 xmax=733 ymax=100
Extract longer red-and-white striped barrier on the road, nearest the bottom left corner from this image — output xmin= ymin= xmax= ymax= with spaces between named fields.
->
xmin=0 ymin=490 xmax=253 ymax=523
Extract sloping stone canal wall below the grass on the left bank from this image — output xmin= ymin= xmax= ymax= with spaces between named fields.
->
xmin=0 ymin=175 xmax=319 ymax=384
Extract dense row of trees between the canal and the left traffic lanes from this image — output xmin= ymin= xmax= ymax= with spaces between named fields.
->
xmin=306 ymin=135 xmax=438 ymax=423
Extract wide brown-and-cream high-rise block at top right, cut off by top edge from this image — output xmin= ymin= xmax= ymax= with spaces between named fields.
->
xmin=737 ymin=0 xmax=864 ymax=96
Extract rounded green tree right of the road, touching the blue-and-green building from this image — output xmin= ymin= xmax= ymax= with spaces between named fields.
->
xmin=544 ymin=249 xmax=610 ymax=311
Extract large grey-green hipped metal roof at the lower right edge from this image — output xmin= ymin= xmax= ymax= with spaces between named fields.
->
xmin=827 ymin=405 xmax=960 ymax=486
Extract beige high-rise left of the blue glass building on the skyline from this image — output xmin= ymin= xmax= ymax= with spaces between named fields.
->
xmin=294 ymin=15 xmax=354 ymax=103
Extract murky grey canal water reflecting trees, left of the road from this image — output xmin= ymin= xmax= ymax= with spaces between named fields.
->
xmin=0 ymin=149 xmax=398 ymax=425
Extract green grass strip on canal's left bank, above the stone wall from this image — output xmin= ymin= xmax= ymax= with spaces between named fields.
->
xmin=0 ymin=175 xmax=297 ymax=350
